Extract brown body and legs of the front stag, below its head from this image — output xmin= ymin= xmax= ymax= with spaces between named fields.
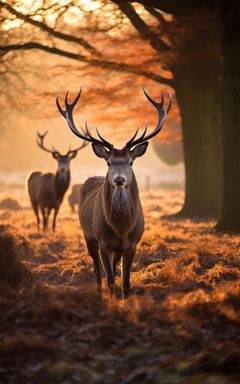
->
xmin=79 ymin=174 xmax=144 ymax=297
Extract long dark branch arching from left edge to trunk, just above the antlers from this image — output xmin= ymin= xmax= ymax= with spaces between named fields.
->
xmin=0 ymin=42 xmax=174 ymax=86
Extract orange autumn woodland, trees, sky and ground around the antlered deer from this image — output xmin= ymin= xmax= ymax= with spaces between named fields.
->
xmin=0 ymin=0 xmax=240 ymax=384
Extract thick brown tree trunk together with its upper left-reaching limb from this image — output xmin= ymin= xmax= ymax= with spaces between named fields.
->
xmin=113 ymin=1 xmax=221 ymax=217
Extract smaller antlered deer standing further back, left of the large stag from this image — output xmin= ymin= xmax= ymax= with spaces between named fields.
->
xmin=27 ymin=132 xmax=87 ymax=231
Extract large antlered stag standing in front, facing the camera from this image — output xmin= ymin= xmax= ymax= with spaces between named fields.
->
xmin=56 ymin=89 xmax=172 ymax=298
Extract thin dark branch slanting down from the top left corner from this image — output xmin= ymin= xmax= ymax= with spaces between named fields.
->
xmin=0 ymin=1 xmax=97 ymax=54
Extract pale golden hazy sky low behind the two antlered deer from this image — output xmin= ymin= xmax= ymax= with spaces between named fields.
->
xmin=0 ymin=115 xmax=183 ymax=184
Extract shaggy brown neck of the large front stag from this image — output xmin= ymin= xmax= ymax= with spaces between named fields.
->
xmin=102 ymin=174 xmax=140 ymax=238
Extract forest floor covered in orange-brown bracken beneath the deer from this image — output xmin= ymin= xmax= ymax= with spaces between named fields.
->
xmin=0 ymin=188 xmax=240 ymax=384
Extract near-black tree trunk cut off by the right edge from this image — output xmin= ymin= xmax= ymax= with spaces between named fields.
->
xmin=217 ymin=0 xmax=240 ymax=230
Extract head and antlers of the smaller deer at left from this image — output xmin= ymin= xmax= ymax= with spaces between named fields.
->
xmin=37 ymin=131 xmax=88 ymax=176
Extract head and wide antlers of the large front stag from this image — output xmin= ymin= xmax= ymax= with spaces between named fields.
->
xmin=56 ymin=88 xmax=172 ymax=188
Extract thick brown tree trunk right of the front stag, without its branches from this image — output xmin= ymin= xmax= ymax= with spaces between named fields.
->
xmin=166 ymin=9 xmax=222 ymax=217
